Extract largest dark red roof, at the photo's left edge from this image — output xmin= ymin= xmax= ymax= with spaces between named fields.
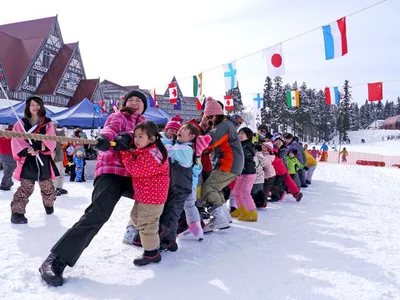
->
xmin=0 ymin=17 xmax=57 ymax=90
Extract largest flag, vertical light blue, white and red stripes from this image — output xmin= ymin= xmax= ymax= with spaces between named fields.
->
xmin=322 ymin=17 xmax=348 ymax=60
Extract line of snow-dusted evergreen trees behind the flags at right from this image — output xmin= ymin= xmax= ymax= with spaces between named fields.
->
xmin=256 ymin=77 xmax=400 ymax=141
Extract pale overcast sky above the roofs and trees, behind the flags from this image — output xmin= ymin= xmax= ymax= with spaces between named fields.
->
xmin=0 ymin=0 xmax=400 ymax=108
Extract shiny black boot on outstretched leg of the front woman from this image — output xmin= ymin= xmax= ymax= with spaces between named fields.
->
xmin=39 ymin=253 xmax=67 ymax=286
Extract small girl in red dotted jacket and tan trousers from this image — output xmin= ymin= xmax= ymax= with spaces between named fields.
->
xmin=121 ymin=121 xmax=169 ymax=266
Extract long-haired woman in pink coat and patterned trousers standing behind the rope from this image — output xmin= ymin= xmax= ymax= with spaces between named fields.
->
xmin=11 ymin=96 xmax=60 ymax=224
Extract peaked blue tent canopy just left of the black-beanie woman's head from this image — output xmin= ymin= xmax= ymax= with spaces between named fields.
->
xmin=51 ymin=98 xmax=108 ymax=128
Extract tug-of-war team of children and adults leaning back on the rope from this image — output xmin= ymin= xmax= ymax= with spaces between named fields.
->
xmin=39 ymin=91 xmax=318 ymax=286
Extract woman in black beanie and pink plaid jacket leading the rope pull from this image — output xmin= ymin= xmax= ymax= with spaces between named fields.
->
xmin=39 ymin=90 xmax=147 ymax=286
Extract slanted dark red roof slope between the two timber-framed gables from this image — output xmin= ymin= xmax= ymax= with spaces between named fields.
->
xmin=36 ymin=43 xmax=77 ymax=94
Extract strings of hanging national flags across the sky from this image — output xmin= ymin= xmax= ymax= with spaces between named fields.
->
xmin=144 ymin=0 xmax=387 ymax=110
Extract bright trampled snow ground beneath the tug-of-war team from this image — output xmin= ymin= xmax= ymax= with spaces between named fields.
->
xmin=0 ymin=148 xmax=400 ymax=300
